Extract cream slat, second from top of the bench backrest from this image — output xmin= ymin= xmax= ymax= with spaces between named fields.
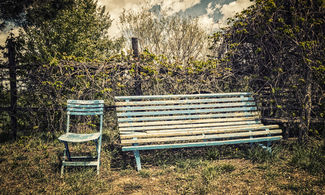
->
xmin=115 ymin=97 xmax=254 ymax=107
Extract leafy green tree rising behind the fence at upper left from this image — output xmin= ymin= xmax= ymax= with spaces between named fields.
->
xmin=21 ymin=0 xmax=118 ymax=63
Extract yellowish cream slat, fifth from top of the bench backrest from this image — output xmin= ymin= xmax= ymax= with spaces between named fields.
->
xmin=118 ymin=112 xmax=259 ymax=124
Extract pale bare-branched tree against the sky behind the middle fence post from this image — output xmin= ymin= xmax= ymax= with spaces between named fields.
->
xmin=120 ymin=7 xmax=208 ymax=63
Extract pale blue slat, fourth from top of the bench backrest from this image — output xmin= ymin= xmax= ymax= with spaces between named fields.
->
xmin=117 ymin=107 xmax=257 ymax=117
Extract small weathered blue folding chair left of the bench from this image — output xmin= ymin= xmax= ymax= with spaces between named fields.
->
xmin=59 ymin=100 xmax=104 ymax=176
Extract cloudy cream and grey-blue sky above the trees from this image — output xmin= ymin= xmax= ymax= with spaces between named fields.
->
xmin=0 ymin=0 xmax=254 ymax=45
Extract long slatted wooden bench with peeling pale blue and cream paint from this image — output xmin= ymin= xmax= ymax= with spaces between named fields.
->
xmin=115 ymin=92 xmax=282 ymax=170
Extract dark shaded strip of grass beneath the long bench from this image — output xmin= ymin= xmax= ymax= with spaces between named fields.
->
xmin=106 ymin=144 xmax=264 ymax=169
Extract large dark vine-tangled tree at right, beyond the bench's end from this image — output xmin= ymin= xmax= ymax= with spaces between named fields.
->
xmin=214 ymin=0 xmax=325 ymax=141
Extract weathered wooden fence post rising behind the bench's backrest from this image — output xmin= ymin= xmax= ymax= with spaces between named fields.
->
xmin=132 ymin=37 xmax=142 ymax=95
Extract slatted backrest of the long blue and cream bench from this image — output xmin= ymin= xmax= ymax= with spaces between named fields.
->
xmin=115 ymin=92 xmax=261 ymax=135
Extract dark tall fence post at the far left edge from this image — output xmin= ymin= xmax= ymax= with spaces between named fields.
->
xmin=7 ymin=38 xmax=17 ymax=139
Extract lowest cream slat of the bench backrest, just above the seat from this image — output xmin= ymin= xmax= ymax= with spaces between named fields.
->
xmin=120 ymin=120 xmax=260 ymax=132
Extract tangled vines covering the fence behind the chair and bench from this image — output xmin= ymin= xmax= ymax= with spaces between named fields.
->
xmin=16 ymin=52 xmax=231 ymax=131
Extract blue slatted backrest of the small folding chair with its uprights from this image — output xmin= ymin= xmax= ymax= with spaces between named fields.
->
xmin=67 ymin=100 xmax=104 ymax=133
